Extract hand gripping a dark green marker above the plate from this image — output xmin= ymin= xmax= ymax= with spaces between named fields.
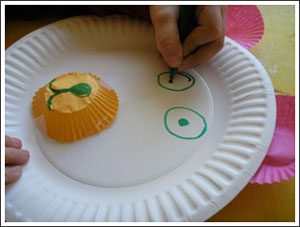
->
xmin=150 ymin=6 xmax=226 ymax=70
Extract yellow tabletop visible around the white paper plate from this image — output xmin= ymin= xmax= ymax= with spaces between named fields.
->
xmin=5 ymin=6 xmax=295 ymax=222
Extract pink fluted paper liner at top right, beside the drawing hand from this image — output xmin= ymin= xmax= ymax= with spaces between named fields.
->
xmin=226 ymin=5 xmax=264 ymax=49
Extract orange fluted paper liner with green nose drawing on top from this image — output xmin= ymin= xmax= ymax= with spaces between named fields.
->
xmin=32 ymin=73 xmax=119 ymax=142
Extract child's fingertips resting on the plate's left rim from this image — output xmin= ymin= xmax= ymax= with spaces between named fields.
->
xmin=5 ymin=136 xmax=29 ymax=184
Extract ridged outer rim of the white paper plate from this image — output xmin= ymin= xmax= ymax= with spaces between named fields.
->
xmin=5 ymin=16 xmax=276 ymax=221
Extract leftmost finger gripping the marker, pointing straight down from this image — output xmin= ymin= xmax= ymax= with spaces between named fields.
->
xmin=150 ymin=6 xmax=183 ymax=68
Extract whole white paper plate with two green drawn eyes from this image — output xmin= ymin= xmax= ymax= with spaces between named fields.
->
xmin=5 ymin=16 xmax=276 ymax=221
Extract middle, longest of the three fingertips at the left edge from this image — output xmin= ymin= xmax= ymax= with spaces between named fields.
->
xmin=5 ymin=147 xmax=29 ymax=165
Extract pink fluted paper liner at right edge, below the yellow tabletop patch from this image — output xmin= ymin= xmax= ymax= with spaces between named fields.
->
xmin=250 ymin=95 xmax=295 ymax=184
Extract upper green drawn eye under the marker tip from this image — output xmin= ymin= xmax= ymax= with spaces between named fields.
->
xmin=157 ymin=71 xmax=195 ymax=91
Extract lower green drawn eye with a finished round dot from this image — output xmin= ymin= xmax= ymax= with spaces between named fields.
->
xmin=164 ymin=106 xmax=207 ymax=140
